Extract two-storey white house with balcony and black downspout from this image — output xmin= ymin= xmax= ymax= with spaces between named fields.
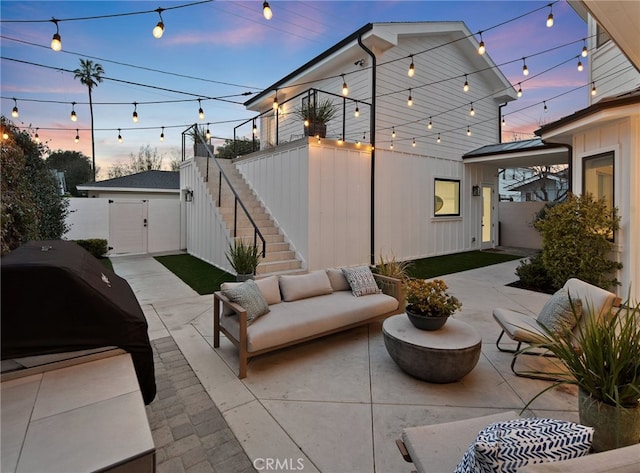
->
xmin=181 ymin=22 xmax=516 ymax=270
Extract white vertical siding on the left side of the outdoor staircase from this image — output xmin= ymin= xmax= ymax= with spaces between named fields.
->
xmin=180 ymin=160 xmax=233 ymax=272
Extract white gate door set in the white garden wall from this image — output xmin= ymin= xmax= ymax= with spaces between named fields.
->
xmin=109 ymin=200 xmax=149 ymax=254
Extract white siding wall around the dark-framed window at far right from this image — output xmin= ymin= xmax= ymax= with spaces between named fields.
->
xmin=572 ymin=114 xmax=640 ymax=300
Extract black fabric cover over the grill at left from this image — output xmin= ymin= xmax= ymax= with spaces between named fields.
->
xmin=0 ymin=240 xmax=156 ymax=404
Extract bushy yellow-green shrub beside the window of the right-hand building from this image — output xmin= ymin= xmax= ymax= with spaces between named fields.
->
xmin=533 ymin=194 xmax=622 ymax=289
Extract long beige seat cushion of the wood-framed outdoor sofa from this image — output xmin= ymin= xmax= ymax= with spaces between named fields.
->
xmin=220 ymin=291 xmax=398 ymax=353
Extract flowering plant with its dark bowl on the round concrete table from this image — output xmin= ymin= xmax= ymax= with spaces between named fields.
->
xmin=404 ymin=279 xmax=462 ymax=330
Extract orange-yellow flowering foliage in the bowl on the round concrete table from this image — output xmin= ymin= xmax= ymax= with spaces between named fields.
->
xmin=404 ymin=279 xmax=462 ymax=317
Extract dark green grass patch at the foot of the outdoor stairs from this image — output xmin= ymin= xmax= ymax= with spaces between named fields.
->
xmin=155 ymin=254 xmax=236 ymax=295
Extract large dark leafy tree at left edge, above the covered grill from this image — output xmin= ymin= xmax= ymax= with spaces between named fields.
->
xmin=0 ymin=116 xmax=69 ymax=254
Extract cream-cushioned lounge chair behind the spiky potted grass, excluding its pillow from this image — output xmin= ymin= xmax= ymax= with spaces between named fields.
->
xmin=493 ymin=278 xmax=621 ymax=380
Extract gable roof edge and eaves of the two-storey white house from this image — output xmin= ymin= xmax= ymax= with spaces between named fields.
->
xmin=244 ymin=21 xmax=516 ymax=109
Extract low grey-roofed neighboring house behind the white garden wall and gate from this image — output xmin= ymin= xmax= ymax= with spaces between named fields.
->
xmin=77 ymin=171 xmax=180 ymax=199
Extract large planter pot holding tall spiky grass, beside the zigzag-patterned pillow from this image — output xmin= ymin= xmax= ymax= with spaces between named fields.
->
xmin=578 ymin=389 xmax=640 ymax=452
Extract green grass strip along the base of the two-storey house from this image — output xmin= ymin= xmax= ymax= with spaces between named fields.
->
xmin=408 ymin=251 xmax=523 ymax=279
